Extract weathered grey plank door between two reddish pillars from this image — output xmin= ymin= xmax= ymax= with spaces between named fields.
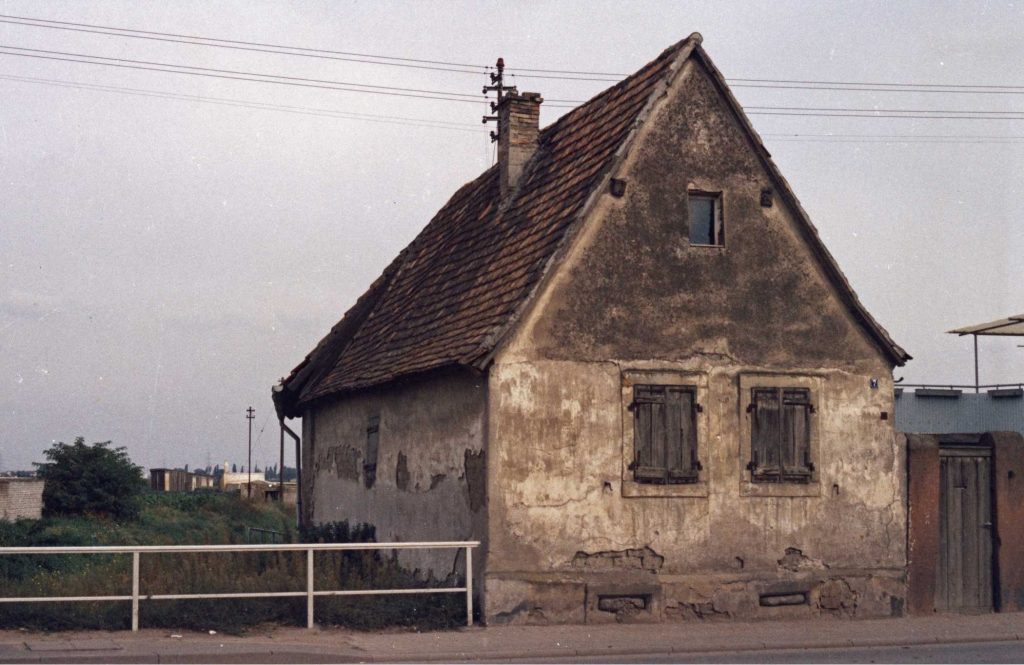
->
xmin=935 ymin=446 xmax=993 ymax=613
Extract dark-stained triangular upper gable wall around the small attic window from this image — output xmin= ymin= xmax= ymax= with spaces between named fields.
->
xmin=504 ymin=55 xmax=890 ymax=373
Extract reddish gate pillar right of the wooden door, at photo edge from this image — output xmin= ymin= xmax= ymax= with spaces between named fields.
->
xmin=982 ymin=431 xmax=1024 ymax=612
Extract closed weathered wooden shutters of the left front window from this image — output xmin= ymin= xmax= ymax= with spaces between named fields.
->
xmin=630 ymin=385 xmax=701 ymax=485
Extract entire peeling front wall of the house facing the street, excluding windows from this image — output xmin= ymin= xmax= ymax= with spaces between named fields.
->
xmin=485 ymin=57 xmax=906 ymax=622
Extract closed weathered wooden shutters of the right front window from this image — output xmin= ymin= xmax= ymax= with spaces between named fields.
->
xmin=748 ymin=388 xmax=814 ymax=483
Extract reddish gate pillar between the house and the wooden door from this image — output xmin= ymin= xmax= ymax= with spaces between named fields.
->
xmin=906 ymin=434 xmax=939 ymax=615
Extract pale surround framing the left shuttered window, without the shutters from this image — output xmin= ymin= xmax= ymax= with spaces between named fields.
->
xmin=621 ymin=369 xmax=709 ymax=498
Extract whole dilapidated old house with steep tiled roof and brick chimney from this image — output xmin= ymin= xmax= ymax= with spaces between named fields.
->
xmin=274 ymin=34 xmax=909 ymax=622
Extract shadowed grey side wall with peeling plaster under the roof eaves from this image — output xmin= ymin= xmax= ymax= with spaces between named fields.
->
xmin=303 ymin=364 xmax=487 ymax=578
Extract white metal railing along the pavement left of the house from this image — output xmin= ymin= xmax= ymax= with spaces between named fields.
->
xmin=0 ymin=540 xmax=480 ymax=631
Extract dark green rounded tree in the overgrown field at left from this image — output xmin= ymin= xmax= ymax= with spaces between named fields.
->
xmin=36 ymin=437 xmax=145 ymax=519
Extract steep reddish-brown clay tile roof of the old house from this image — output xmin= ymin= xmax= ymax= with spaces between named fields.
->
xmin=274 ymin=34 xmax=902 ymax=416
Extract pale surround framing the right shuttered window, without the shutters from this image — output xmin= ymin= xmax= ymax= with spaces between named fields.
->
xmin=738 ymin=372 xmax=827 ymax=497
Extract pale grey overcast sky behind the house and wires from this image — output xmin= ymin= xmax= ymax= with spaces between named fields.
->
xmin=0 ymin=0 xmax=1024 ymax=469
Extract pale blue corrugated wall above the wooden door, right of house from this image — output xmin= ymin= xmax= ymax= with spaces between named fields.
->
xmin=895 ymin=390 xmax=1024 ymax=434
